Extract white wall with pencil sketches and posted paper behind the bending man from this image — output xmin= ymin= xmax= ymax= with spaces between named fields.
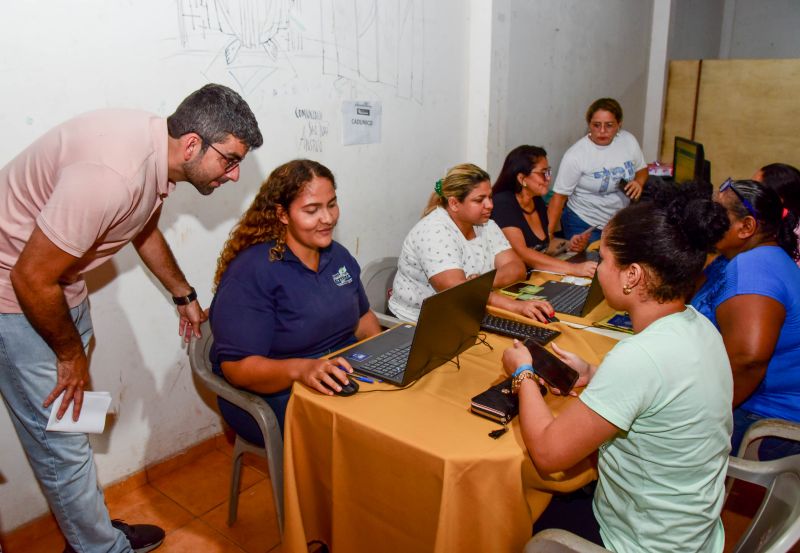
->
xmin=0 ymin=0 xmax=468 ymax=532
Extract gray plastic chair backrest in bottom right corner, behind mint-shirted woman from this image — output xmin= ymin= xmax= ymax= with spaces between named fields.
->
xmin=728 ymin=455 xmax=800 ymax=553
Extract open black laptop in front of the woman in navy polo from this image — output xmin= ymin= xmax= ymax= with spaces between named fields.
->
xmin=339 ymin=270 xmax=496 ymax=386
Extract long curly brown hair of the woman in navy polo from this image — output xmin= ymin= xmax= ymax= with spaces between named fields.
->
xmin=214 ymin=159 xmax=336 ymax=290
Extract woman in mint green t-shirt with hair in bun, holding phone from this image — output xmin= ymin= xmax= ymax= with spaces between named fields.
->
xmin=503 ymin=183 xmax=733 ymax=552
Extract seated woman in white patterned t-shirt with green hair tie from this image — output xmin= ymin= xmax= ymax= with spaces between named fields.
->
xmin=389 ymin=163 xmax=555 ymax=322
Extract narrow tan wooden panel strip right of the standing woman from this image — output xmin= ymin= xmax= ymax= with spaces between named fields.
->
xmin=659 ymin=60 xmax=700 ymax=163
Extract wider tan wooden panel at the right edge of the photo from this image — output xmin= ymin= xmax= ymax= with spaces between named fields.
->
xmin=695 ymin=59 xmax=800 ymax=184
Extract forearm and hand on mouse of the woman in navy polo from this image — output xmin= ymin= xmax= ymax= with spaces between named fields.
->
xmin=221 ymin=355 xmax=353 ymax=395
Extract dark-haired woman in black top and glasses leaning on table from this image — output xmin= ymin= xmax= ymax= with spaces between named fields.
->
xmin=492 ymin=145 xmax=597 ymax=277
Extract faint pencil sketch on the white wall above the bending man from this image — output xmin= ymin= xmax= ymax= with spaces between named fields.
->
xmin=177 ymin=0 xmax=424 ymax=104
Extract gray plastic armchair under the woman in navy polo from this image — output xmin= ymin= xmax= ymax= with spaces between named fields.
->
xmin=189 ymin=321 xmax=283 ymax=538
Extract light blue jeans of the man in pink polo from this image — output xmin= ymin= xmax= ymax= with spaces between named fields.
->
xmin=0 ymin=300 xmax=131 ymax=553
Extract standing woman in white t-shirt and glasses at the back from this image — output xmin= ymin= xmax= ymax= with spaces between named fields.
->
xmin=547 ymin=98 xmax=647 ymax=251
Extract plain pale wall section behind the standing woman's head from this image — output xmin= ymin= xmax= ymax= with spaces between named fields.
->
xmin=504 ymin=0 xmax=652 ymax=180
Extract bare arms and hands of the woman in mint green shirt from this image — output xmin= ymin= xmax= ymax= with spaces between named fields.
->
xmin=503 ymin=341 xmax=619 ymax=474
